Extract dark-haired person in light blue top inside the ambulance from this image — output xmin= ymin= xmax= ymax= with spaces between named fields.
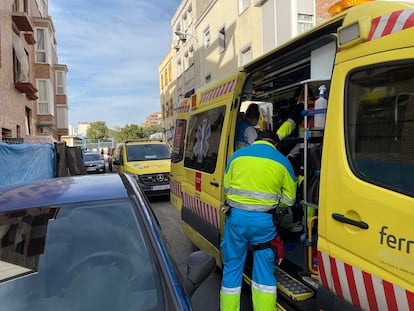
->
xmin=235 ymin=104 xmax=260 ymax=150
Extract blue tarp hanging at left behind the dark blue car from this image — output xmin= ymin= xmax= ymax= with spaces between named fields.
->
xmin=0 ymin=142 xmax=56 ymax=186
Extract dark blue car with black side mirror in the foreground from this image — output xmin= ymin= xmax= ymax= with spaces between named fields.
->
xmin=0 ymin=174 xmax=216 ymax=311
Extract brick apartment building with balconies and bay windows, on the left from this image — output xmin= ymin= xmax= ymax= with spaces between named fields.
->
xmin=0 ymin=0 xmax=69 ymax=141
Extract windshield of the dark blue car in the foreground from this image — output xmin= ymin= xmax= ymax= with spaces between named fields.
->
xmin=0 ymin=201 xmax=167 ymax=311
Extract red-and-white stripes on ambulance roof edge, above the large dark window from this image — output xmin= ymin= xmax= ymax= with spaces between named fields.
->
xmin=367 ymin=10 xmax=414 ymax=41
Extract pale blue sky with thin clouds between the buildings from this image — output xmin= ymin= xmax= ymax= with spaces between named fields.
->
xmin=49 ymin=0 xmax=180 ymax=128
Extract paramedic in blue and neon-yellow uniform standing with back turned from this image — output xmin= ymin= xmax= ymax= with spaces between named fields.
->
xmin=220 ymin=131 xmax=296 ymax=311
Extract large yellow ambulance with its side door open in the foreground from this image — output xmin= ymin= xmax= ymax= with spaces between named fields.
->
xmin=171 ymin=1 xmax=414 ymax=310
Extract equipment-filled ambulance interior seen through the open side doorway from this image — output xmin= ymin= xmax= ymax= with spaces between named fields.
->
xmin=240 ymin=36 xmax=336 ymax=300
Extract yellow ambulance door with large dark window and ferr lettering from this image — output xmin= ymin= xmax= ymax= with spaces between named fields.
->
xmin=318 ymin=48 xmax=414 ymax=310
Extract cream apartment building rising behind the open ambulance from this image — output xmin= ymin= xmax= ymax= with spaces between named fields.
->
xmin=159 ymin=0 xmax=316 ymax=136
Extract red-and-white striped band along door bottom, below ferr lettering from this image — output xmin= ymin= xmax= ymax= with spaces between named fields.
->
xmin=318 ymin=251 xmax=414 ymax=311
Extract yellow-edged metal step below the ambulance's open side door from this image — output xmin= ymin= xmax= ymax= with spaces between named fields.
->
xmin=275 ymin=267 xmax=314 ymax=300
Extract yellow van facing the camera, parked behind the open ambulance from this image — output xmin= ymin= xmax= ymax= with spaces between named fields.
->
xmin=113 ymin=140 xmax=171 ymax=196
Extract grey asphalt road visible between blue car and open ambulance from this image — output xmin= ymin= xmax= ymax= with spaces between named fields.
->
xmin=150 ymin=198 xmax=253 ymax=311
